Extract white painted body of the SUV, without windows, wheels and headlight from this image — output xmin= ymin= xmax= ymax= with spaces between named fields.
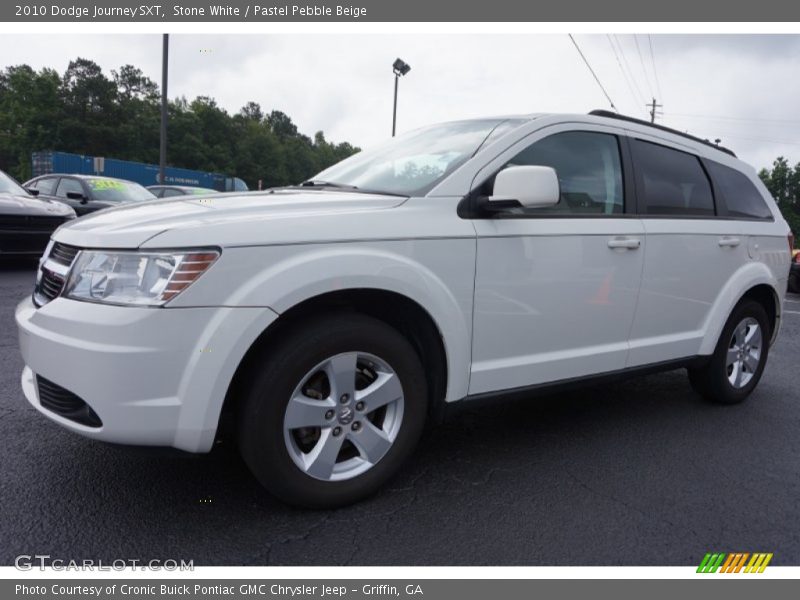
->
xmin=16 ymin=115 xmax=789 ymax=452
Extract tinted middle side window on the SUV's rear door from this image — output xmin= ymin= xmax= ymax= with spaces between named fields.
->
xmin=633 ymin=140 xmax=714 ymax=217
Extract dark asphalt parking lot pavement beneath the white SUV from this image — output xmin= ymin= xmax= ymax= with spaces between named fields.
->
xmin=0 ymin=264 xmax=800 ymax=565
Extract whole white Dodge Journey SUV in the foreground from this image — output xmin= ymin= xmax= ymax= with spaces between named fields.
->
xmin=16 ymin=112 xmax=790 ymax=507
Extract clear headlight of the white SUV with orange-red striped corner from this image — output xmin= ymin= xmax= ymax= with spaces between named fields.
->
xmin=64 ymin=250 xmax=219 ymax=306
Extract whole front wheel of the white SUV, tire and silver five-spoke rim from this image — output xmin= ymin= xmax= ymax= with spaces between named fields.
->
xmin=239 ymin=315 xmax=427 ymax=508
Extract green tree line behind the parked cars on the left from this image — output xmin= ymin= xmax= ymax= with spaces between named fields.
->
xmin=0 ymin=58 xmax=359 ymax=189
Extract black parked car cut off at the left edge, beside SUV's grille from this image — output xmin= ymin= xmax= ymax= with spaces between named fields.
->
xmin=0 ymin=171 xmax=75 ymax=257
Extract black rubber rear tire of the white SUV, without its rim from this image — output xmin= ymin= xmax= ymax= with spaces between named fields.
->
xmin=689 ymin=299 xmax=772 ymax=404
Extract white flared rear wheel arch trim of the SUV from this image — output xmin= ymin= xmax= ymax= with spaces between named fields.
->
xmin=699 ymin=262 xmax=783 ymax=355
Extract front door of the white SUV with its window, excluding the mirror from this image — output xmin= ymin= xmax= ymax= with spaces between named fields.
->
xmin=470 ymin=124 xmax=644 ymax=394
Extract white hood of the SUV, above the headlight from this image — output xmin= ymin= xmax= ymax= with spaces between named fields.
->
xmin=55 ymin=190 xmax=406 ymax=248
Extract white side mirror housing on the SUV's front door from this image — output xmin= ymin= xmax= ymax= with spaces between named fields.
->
xmin=489 ymin=166 xmax=561 ymax=208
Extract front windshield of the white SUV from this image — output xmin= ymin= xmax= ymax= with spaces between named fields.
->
xmin=312 ymin=119 xmax=520 ymax=196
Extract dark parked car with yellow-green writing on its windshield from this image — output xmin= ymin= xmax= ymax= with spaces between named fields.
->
xmin=25 ymin=173 xmax=155 ymax=216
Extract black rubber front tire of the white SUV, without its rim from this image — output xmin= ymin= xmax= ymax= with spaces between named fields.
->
xmin=238 ymin=314 xmax=427 ymax=508
